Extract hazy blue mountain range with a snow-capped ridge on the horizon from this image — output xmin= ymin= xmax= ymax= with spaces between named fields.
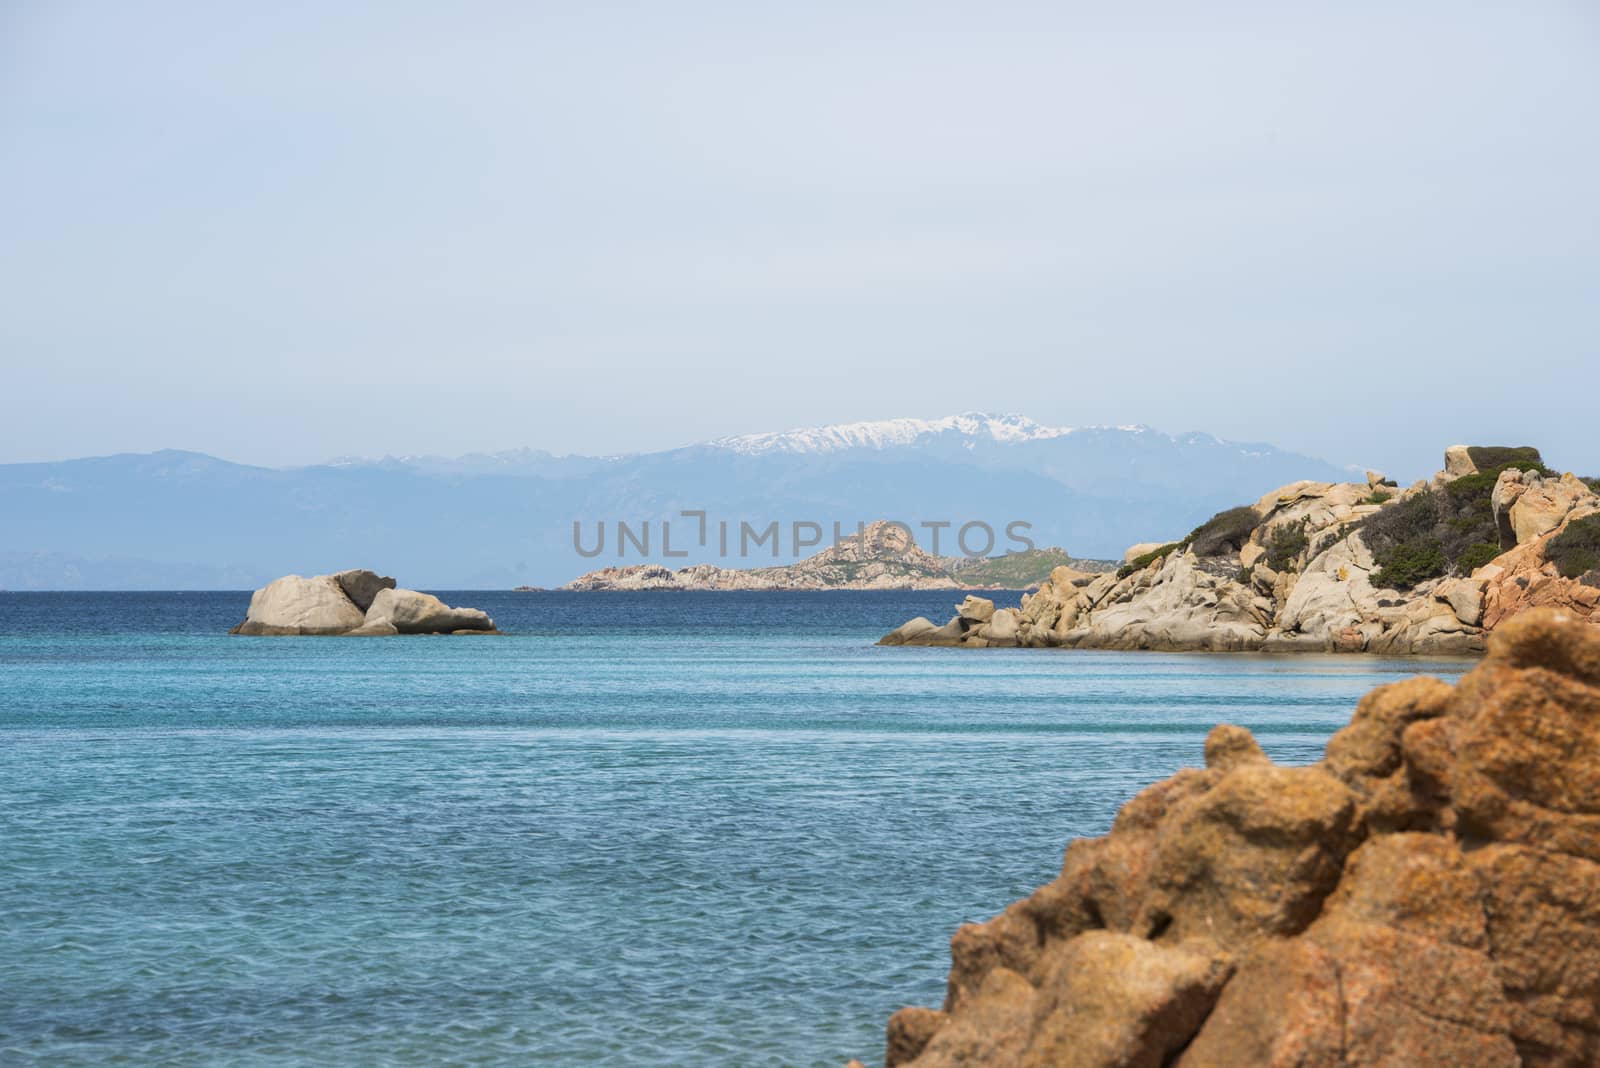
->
xmin=0 ymin=412 xmax=1347 ymax=590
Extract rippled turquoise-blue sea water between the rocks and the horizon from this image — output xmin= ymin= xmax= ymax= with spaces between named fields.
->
xmin=0 ymin=592 xmax=1467 ymax=1068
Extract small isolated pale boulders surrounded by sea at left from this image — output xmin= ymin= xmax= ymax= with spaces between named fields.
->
xmin=229 ymin=571 xmax=499 ymax=638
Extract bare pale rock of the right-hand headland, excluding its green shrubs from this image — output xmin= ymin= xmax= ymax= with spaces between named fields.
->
xmin=882 ymin=446 xmax=1600 ymax=656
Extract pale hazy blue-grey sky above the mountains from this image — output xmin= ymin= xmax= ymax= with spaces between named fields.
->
xmin=0 ymin=0 xmax=1600 ymax=476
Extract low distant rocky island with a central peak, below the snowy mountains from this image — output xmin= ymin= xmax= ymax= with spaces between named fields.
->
xmin=562 ymin=520 xmax=1117 ymax=593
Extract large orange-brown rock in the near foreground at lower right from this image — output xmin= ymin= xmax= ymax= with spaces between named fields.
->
xmin=857 ymin=609 xmax=1600 ymax=1068
